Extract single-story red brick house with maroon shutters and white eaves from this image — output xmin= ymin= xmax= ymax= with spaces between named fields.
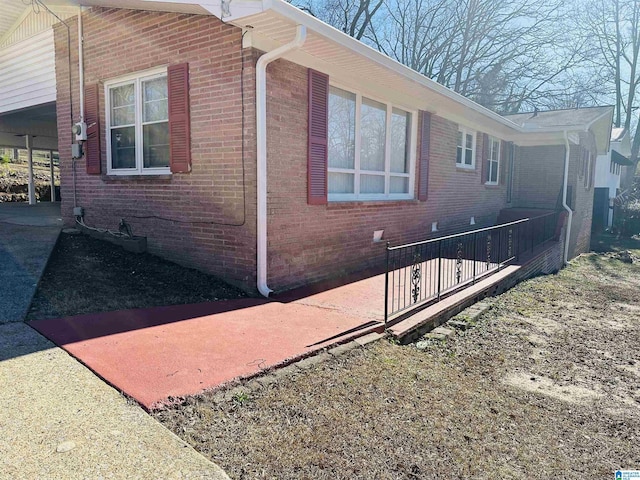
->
xmin=8 ymin=0 xmax=612 ymax=294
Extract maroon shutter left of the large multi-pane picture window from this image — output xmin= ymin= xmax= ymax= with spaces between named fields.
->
xmin=307 ymin=69 xmax=329 ymax=205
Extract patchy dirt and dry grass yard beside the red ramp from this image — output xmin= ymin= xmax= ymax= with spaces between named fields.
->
xmin=156 ymin=239 xmax=640 ymax=480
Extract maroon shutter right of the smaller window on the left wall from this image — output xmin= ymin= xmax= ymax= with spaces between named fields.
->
xmin=167 ymin=63 xmax=191 ymax=173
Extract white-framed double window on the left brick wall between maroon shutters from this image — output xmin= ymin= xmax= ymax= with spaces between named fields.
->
xmin=105 ymin=69 xmax=170 ymax=175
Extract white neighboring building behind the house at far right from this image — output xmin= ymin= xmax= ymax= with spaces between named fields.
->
xmin=592 ymin=128 xmax=633 ymax=231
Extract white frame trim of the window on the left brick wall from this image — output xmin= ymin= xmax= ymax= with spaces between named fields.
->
xmin=104 ymin=66 xmax=171 ymax=176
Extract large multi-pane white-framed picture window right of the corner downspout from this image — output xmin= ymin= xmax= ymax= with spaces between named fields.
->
xmin=328 ymin=86 xmax=413 ymax=201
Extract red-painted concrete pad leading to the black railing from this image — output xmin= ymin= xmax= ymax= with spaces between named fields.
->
xmin=31 ymin=277 xmax=384 ymax=409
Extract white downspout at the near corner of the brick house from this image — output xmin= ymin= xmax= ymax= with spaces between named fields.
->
xmin=256 ymin=25 xmax=307 ymax=297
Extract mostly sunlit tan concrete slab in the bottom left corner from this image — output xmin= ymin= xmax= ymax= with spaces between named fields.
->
xmin=0 ymin=323 xmax=228 ymax=480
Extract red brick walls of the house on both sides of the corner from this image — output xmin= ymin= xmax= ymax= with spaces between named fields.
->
xmin=55 ymin=8 xmax=590 ymax=290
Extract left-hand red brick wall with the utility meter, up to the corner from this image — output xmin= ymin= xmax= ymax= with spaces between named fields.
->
xmin=55 ymin=8 xmax=256 ymax=287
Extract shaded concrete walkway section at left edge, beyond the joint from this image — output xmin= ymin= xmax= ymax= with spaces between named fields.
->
xmin=0 ymin=203 xmax=62 ymax=324
